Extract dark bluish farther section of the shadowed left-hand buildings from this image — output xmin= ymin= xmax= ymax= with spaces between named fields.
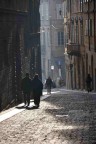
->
xmin=27 ymin=0 xmax=42 ymax=79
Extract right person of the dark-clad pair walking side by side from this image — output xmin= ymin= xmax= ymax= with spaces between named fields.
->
xmin=32 ymin=74 xmax=43 ymax=108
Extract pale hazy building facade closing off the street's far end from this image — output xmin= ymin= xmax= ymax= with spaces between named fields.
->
xmin=40 ymin=0 xmax=65 ymax=82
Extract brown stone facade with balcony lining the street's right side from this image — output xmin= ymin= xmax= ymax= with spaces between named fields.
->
xmin=63 ymin=0 xmax=96 ymax=91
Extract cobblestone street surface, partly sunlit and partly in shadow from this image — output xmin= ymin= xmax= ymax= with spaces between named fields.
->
xmin=0 ymin=90 xmax=96 ymax=144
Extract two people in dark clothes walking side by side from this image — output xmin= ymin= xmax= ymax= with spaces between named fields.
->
xmin=21 ymin=73 xmax=43 ymax=108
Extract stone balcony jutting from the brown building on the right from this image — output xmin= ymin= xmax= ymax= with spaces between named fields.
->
xmin=67 ymin=43 xmax=80 ymax=56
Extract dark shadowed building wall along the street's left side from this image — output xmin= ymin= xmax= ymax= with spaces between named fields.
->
xmin=0 ymin=0 xmax=41 ymax=109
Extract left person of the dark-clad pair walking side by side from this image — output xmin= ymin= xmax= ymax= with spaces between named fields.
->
xmin=21 ymin=73 xmax=31 ymax=106
